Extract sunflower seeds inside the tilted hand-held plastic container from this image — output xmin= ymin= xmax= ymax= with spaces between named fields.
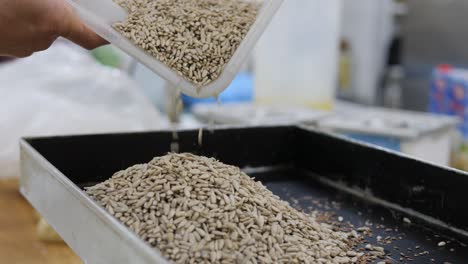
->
xmin=114 ymin=0 xmax=260 ymax=87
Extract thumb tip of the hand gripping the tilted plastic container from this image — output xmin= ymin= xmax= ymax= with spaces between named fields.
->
xmin=62 ymin=8 xmax=107 ymax=49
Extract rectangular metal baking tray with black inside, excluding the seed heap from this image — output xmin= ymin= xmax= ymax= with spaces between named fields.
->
xmin=21 ymin=126 xmax=468 ymax=263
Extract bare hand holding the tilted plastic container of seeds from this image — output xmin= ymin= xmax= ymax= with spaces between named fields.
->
xmin=0 ymin=0 xmax=106 ymax=57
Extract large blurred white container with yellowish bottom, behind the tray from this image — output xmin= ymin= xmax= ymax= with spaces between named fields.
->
xmin=254 ymin=0 xmax=342 ymax=110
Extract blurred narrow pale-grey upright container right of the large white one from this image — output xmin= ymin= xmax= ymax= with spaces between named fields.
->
xmin=341 ymin=0 xmax=394 ymax=104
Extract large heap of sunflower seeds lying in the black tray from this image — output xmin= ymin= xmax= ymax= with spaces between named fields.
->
xmin=86 ymin=154 xmax=364 ymax=263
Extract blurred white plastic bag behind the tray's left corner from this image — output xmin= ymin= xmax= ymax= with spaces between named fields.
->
xmin=0 ymin=42 xmax=163 ymax=178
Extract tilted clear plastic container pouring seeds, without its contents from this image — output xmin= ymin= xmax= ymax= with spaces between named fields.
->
xmin=67 ymin=0 xmax=283 ymax=98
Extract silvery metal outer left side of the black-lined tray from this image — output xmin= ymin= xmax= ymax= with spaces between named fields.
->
xmin=20 ymin=139 xmax=169 ymax=263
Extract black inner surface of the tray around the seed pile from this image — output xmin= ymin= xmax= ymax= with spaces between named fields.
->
xmin=26 ymin=126 xmax=468 ymax=263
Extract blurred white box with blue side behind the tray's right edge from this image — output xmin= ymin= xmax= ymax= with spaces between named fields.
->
xmin=319 ymin=102 xmax=459 ymax=166
